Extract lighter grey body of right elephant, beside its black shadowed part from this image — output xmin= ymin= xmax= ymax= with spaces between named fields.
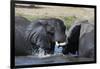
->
xmin=79 ymin=22 xmax=95 ymax=58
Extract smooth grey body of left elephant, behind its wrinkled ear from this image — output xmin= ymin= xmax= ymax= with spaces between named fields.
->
xmin=15 ymin=16 xmax=32 ymax=56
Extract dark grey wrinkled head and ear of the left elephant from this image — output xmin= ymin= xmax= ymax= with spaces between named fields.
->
xmin=25 ymin=18 xmax=66 ymax=55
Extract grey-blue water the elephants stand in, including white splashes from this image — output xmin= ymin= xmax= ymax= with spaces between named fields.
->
xmin=15 ymin=46 xmax=94 ymax=66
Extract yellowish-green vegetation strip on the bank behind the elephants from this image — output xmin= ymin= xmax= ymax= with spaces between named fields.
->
xmin=16 ymin=13 xmax=75 ymax=29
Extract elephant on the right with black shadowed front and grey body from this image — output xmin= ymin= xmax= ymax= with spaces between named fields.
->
xmin=63 ymin=20 xmax=94 ymax=57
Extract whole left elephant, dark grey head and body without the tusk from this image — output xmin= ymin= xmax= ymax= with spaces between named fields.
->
xmin=15 ymin=17 xmax=66 ymax=55
